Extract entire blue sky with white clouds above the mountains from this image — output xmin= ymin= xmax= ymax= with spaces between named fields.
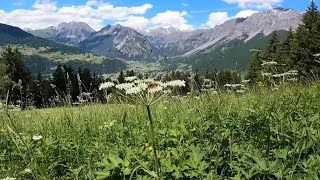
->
xmin=0 ymin=0 xmax=310 ymax=30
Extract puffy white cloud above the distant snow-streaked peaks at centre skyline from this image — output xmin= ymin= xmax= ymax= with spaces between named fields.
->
xmin=151 ymin=10 xmax=194 ymax=30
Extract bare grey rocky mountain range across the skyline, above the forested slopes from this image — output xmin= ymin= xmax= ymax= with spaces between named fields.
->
xmin=30 ymin=8 xmax=302 ymax=60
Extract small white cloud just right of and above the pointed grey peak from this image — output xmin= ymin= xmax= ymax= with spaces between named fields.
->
xmin=115 ymin=16 xmax=150 ymax=30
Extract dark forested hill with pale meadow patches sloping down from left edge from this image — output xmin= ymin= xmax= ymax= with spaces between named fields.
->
xmin=0 ymin=23 xmax=127 ymax=74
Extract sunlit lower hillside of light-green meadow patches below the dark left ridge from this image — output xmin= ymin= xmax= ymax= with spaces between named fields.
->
xmin=0 ymin=45 xmax=127 ymax=74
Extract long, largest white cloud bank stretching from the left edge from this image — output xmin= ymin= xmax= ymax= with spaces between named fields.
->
xmin=0 ymin=0 xmax=153 ymax=30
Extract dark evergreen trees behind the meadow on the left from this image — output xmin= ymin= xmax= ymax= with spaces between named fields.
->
xmin=0 ymin=47 xmax=103 ymax=108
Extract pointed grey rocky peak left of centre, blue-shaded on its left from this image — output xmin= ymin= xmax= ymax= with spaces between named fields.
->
xmin=80 ymin=25 xmax=156 ymax=60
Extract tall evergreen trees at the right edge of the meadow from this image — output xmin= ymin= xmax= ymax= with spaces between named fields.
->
xmin=246 ymin=1 xmax=320 ymax=83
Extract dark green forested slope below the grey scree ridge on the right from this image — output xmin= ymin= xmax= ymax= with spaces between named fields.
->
xmin=171 ymin=31 xmax=287 ymax=73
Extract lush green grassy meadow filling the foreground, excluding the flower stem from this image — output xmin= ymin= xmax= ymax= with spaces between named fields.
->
xmin=0 ymin=85 xmax=320 ymax=180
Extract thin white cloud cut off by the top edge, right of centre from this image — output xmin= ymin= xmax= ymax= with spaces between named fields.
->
xmin=223 ymin=0 xmax=284 ymax=9
